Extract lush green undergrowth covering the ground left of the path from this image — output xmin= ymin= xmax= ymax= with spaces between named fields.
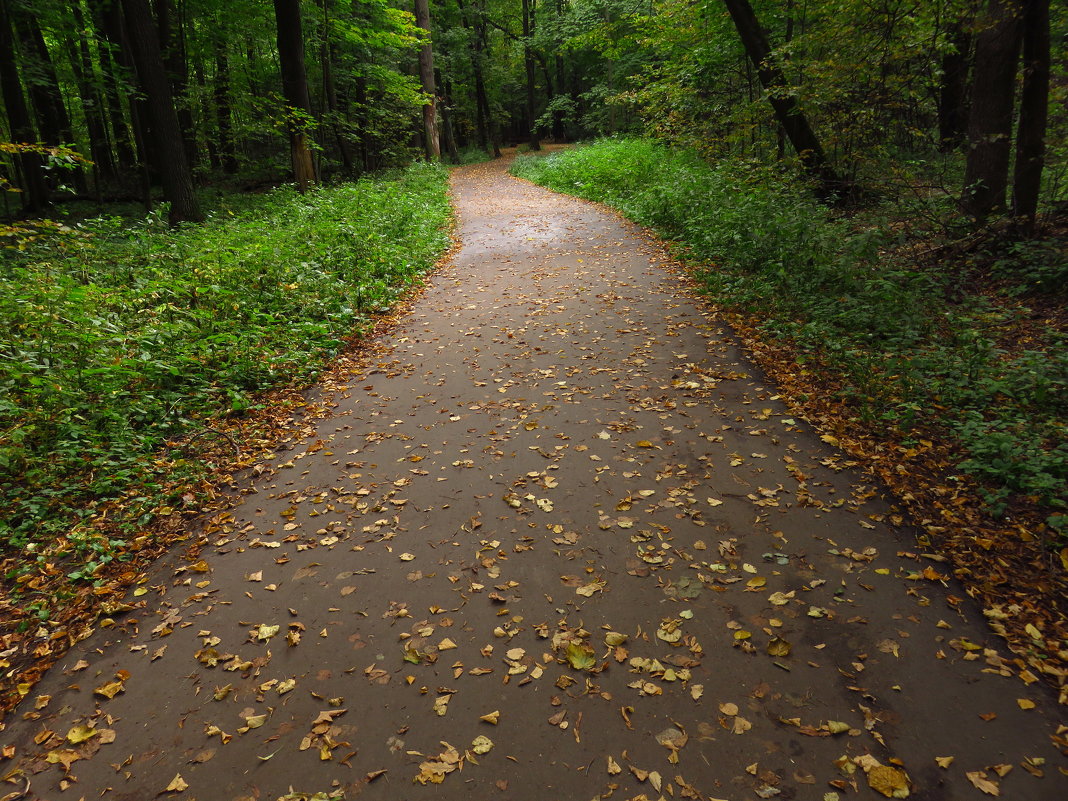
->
xmin=0 ymin=163 xmax=451 ymax=579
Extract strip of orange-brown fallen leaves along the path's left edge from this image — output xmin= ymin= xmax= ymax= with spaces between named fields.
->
xmin=0 ymin=233 xmax=458 ymax=717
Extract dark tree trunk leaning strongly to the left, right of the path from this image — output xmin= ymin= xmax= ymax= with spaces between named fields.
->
xmin=723 ymin=0 xmax=845 ymax=197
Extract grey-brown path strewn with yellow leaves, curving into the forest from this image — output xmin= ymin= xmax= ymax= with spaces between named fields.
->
xmin=0 ymin=156 xmax=1068 ymax=801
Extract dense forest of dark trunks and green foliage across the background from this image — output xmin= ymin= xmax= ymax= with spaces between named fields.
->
xmin=0 ymin=0 xmax=1068 ymax=229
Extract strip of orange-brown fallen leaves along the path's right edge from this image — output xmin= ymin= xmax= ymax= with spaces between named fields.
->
xmin=645 ymin=244 xmax=1068 ymax=705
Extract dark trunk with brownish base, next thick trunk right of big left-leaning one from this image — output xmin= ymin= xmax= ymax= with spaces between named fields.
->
xmin=274 ymin=0 xmax=316 ymax=192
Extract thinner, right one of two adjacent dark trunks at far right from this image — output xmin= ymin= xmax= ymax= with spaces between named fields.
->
xmin=1012 ymin=0 xmax=1050 ymax=234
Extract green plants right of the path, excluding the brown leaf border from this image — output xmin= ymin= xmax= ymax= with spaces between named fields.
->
xmin=513 ymin=139 xmax=1068 ymax=544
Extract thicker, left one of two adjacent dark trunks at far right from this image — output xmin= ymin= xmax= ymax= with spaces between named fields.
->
xmin=960 ymin=0 xmax=1023 ymax=222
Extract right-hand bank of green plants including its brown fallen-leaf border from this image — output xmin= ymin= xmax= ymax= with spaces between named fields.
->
xmin=513 ymin=139 xmax=1068 ymax=670
